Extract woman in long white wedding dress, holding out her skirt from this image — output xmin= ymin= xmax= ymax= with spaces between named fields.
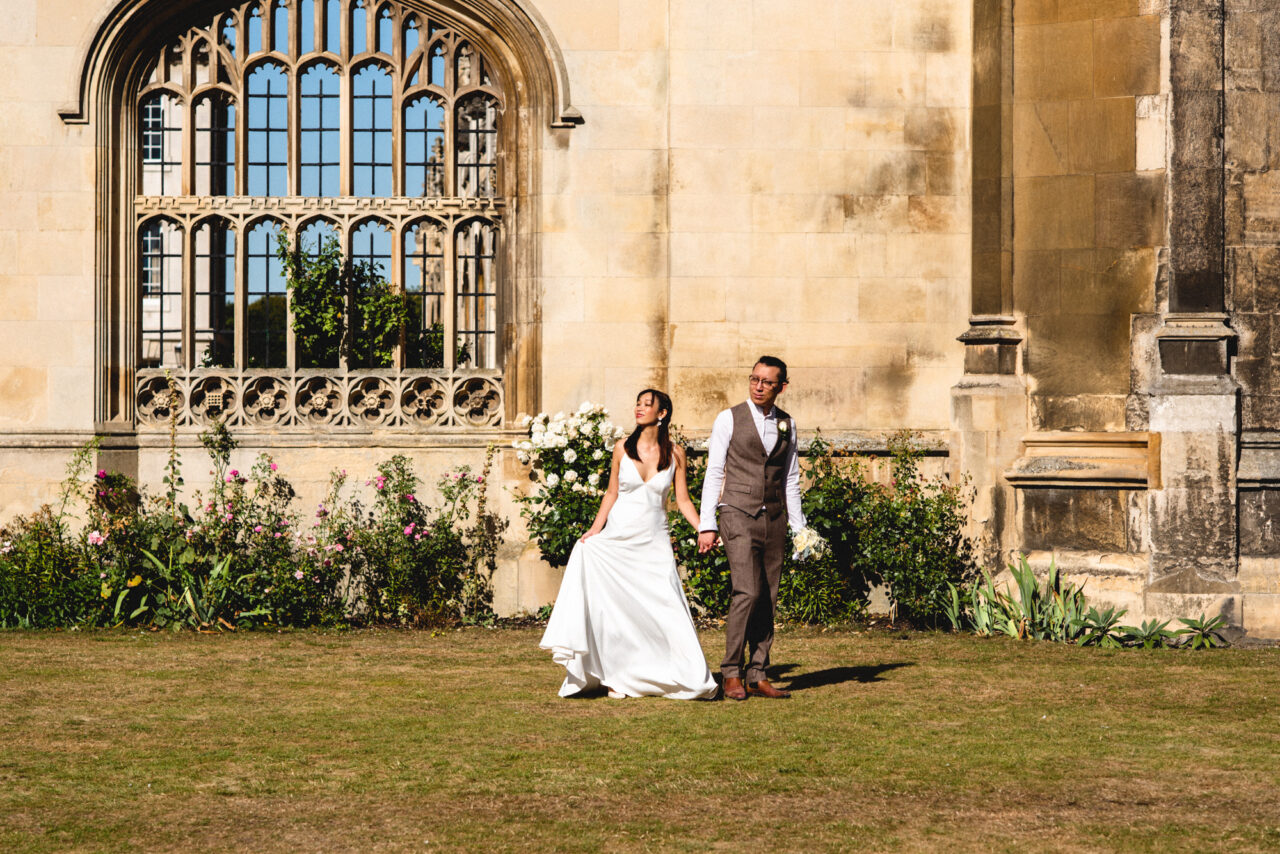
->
xmin=539 ymin=388 xmax=717 ymax=699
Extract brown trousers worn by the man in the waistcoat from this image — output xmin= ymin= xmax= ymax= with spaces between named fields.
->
xmin=719 ymin=504 xmax=787 ymax=682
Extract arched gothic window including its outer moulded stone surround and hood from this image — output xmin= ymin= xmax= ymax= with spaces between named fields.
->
xmin=61 ymin=0 xmax=572 ymax=429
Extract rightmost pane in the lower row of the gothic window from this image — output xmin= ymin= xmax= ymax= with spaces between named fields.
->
xmin=454 ymin=220 xmax=498 ymax=367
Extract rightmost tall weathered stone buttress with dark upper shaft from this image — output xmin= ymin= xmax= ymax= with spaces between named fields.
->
xmin=1134 ymin=0 xmax=1242 ymax=624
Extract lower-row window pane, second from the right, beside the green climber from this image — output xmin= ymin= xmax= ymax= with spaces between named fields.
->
xmin=403 ymin=223 xmax=444 ymax=367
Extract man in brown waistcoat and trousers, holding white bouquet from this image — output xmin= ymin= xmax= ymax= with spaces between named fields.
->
xmin=698 ymin=356 xmax=805 ymax=700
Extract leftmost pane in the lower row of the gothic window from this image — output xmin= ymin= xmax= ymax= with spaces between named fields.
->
xmin=138 ymin=220 xmax=182 ymax=367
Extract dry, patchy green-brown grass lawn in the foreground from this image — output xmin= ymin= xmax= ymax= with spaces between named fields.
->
xmin=0 ymin=630 xmax=1280 ymax=851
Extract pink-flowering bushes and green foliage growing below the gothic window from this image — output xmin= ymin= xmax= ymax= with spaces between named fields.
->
xmin=0 ymin=424 xmax=506 ymax=631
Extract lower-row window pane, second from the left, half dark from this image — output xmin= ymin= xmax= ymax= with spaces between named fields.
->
xmin=192 ymin=222 xmax=236 ymax=367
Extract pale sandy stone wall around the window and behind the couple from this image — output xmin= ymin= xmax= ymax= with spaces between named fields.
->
xmin=0 ymin=0 xmax=972 ymax=612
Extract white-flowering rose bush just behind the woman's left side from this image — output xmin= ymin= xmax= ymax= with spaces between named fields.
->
xmin=512 ymin=402 xmax=626 ymax=566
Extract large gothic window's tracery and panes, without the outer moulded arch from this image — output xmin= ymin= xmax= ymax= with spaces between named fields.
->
xmin=127 ymin=0 xmax=507 ymax=428
